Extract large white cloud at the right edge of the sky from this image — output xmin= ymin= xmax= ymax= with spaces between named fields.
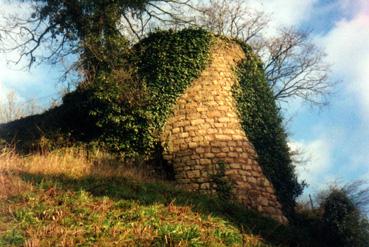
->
xmin=318 ymin=12 xmax=369 ymax=121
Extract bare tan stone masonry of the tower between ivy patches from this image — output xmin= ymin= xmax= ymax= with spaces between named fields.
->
xmin=161 ymin=39 xmax=287 ymax=223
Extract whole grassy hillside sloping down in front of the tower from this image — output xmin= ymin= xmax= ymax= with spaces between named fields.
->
xmin=0 ymin=148 xmax=294 ymax=246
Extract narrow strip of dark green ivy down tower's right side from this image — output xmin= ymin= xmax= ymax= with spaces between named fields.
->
xmin=233 ymin=44 xmax=304 ymax=216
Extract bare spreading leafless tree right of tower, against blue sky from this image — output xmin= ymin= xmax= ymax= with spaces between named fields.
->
xmin=259 ymin=29 xmax=335 ymax=105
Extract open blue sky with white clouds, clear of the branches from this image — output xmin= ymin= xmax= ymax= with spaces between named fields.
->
xmin=0 ymin=0 xmax=369 ymax=198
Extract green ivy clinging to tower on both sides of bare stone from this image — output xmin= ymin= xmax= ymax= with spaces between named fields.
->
xmin=135 ymin=29 xmax=303 ymax=215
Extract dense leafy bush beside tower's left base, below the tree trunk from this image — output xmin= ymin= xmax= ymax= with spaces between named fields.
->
xmin=62 ymin=70 xmax=152 ymax=157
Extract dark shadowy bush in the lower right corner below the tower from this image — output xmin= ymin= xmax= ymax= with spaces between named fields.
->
xmin=293 ymin=184 xmax=369 ymax=247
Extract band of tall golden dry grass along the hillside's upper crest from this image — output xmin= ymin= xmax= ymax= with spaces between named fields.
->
xmin=0 ymin=147 xmax=157 ymax=200
